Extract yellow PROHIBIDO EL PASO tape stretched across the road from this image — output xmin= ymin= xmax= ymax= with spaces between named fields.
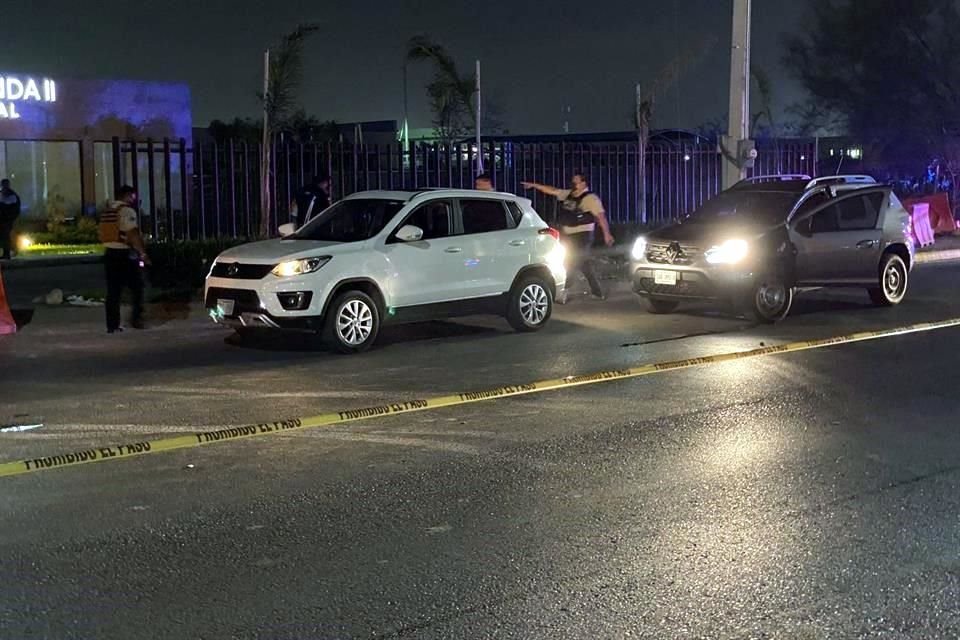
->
xmin=0 ymin=318 xmax=960 ymax=477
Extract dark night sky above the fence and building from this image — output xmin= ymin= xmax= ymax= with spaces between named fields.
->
xmin=0 ymin=0 xmax=804 ymax=133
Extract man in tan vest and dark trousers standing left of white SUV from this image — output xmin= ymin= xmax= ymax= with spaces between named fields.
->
xmin=99 ymin=185 xmax=150 ymax=333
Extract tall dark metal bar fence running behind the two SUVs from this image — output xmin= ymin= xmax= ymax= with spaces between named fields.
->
xmin=105 ymin=140 xmax=816 ymax=239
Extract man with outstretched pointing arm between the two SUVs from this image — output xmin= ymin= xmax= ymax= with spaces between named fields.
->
xmin=521 ymin=173 xmax=614 ymax=303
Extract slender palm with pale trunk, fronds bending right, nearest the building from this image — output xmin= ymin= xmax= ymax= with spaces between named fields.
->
xmin=260 ymin=24 xmax=319 ymax=238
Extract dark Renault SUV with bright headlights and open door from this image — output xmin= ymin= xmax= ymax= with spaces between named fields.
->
xmin=631 ymin=175 xmax=914 ymax=322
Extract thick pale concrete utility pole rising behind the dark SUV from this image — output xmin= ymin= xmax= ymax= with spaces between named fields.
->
xmin=723 ymin=0 xmax=756 ymax=189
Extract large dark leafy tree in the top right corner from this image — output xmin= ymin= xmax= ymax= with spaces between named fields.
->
xmin=784 ymin=0 xmax=960 ymax=204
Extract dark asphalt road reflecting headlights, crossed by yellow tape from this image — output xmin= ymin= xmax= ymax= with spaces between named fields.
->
xmin=0 ymin=265 xmax=960 ymax=639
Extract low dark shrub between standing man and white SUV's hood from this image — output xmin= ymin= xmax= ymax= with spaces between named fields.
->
xmin=147 ymin=238 xmax=246 ymax=290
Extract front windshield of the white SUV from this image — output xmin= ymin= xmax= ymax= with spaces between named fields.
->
xmin=290 ymin=198 xmax=406 ymax=242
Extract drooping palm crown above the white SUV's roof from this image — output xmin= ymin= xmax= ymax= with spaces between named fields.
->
xmin=407 ymin=36 xmax=477 ymax=143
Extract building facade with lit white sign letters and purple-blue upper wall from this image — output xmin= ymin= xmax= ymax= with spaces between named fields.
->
xmin=0 ymin=70 xmax=193 ymax=219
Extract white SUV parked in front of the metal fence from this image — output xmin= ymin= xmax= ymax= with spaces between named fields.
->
xmin=204 ymin=189 xmax=566 ymax=353
